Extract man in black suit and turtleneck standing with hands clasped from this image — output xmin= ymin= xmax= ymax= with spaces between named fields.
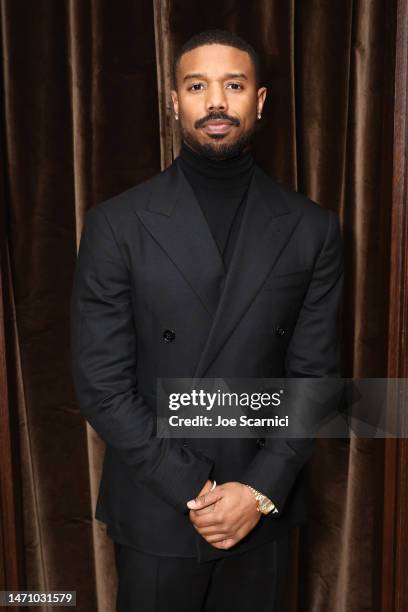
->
xmin=71 ymin=30 xmax=343 ymax=612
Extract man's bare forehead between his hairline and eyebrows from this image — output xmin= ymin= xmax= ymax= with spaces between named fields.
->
xmin=178 ymin=44 xmax=254 ymax=79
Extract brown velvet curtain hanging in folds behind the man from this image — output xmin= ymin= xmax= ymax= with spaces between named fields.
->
xmin=0 ymin=0 xmax=394 ymax=612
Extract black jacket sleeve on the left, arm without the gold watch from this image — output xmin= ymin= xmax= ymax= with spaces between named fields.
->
xmin=71 ymin=206 xmax=213 ymax=513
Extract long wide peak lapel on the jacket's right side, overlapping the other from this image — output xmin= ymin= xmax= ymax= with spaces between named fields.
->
xmin=194 ymin=166 xmax=301 ymax=379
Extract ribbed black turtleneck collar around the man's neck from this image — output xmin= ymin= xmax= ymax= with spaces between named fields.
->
xmin=179 ymin=141 xmax=255 ymax=190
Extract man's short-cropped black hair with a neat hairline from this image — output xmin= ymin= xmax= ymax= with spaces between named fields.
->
xmin=172 ymin=29 xmax=261 ymax=88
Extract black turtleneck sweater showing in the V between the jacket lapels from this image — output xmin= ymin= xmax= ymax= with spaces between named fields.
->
xmin=179 ymin=142 xmax=255 ymax=258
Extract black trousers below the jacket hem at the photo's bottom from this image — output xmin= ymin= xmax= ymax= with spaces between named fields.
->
xmin=114 ymin=534 xmax=290 ymax=612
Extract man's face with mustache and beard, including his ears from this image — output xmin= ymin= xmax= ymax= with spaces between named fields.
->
xmin=171 ymin=44 xmax=266 ymax=159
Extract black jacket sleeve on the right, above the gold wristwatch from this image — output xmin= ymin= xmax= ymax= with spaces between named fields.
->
xmin=241 ymin=210 xmax=344 ymax=517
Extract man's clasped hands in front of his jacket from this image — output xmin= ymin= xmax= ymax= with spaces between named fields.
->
xmin=187 ymin=480 xmax=261 ymax=549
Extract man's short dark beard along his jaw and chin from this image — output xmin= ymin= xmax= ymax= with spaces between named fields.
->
xmin=180 ymin=123 xmax=260 ymax=161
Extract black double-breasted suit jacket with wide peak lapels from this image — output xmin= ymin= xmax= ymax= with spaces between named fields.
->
xmin=71 ymin=155 xmax=343 ymax=561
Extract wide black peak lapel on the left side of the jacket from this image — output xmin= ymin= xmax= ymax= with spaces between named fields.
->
xmin=136 ymin=160 xmax=225 ymax=316
